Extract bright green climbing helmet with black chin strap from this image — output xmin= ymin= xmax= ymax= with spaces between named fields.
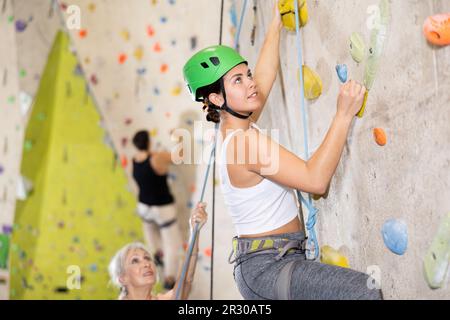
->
xmin=183 ymin=45 xmax=247 ymax=101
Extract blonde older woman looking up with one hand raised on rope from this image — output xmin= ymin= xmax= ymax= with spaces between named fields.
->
xmin=109 ymin=203 xmax=207 ymax=300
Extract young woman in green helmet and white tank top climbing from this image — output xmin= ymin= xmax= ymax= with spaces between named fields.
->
xmin=183 ymin=6 xmax=382 ymax=299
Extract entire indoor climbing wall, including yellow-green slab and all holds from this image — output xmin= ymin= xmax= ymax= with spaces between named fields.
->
xmin=0 ymin=0 xmax=450 ymax=299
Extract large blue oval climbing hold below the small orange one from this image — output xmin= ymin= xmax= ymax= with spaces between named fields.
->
xmin=381 ymin=219 xmax=408 ymax=255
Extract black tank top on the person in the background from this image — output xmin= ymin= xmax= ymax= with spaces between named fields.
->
xmin=133 ymin=156 xmax=174 ymax=206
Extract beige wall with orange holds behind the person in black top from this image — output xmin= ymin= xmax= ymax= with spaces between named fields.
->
xmin=54 ymin=0 xmax=238 ymax=299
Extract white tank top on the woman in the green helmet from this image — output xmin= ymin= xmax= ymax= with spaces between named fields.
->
xmin=218 ymin=124 xmax=298 ymax=236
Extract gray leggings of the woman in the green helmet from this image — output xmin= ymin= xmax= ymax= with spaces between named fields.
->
xmin=234 ymin=232 xmax=383 ymax=300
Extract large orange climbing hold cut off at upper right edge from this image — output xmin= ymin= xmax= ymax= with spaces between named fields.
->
xmin=423 ymin=13 xmax=450 ymax=46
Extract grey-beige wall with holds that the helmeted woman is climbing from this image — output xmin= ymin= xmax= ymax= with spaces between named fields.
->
xmin=234 ymin=0 xmax=450 ymax=299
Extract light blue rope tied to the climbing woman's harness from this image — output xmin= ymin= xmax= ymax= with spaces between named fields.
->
xmin=295 ymin=0 xmax=319 ymax=259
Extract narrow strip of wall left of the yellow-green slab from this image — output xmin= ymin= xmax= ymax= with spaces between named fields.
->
xmin=0 ymin=0 xmax=59 ymax=299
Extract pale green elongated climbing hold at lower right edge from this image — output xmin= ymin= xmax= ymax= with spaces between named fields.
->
xmin=423 ymin=213 xmax=450 ymax=289
